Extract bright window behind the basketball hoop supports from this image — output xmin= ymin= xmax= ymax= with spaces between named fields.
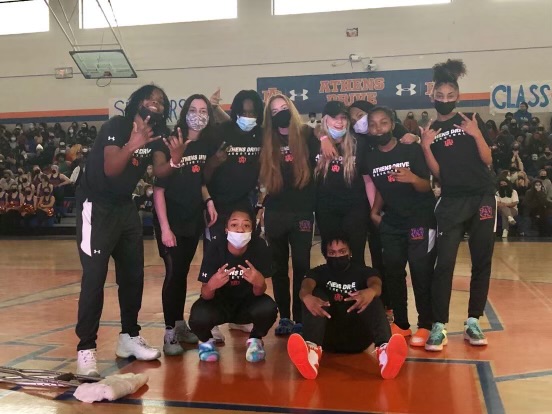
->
xmin=80 ymin=0 xmax=238 ymax=29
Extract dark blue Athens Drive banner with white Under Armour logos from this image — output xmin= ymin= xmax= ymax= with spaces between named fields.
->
xmin=257 ymin=69 xmax=433 ymax=114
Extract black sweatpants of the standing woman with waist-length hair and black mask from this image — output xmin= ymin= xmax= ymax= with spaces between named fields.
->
xmin=264 ymin=209 xmax=314 ymax=322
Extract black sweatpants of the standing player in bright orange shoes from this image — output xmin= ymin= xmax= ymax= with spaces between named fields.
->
xmin=379 ymin=221 xmax=437 ymax=329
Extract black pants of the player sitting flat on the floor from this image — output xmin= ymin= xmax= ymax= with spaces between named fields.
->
xmin=303 ymin=287 xmax=391 ymax=354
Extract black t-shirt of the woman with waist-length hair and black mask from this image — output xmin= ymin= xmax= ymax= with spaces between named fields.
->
xmin=264 ymin=125 xmax=320 ymax=213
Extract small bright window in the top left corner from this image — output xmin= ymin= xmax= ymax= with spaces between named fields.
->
xmin=0 ymin=0 xmax=50 ymax=35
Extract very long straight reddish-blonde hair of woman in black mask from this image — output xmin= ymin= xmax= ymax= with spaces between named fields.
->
xmin=259 ymin=94 xmax=311 ymax=194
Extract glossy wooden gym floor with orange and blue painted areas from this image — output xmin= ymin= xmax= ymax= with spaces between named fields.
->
xmin=0 ymin=239 xmax=552 ymax=414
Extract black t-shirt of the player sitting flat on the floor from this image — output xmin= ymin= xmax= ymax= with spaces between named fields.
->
xmin=305 ymin=263 xmax=379 ymax=308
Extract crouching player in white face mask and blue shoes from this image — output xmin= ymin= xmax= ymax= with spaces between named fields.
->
xmin=190 ymin=209 xmax=278 ymax=362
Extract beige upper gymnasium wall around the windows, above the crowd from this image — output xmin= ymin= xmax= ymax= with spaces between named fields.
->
xmin=0 ymin=0 xmax=552 ymax=122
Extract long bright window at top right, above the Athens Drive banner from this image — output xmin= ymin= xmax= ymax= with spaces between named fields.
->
xmin=272 ymin=0 xmax=452 ymax=15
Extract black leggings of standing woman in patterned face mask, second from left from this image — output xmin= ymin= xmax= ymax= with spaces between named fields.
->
xmin=153 ymin=215 xmax=201 ymax=327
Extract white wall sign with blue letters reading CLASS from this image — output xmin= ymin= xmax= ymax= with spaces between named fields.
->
xmin=489 ymin=81 xmax=552 ymax=113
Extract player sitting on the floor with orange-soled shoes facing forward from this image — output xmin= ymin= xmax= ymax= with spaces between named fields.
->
xmin=287 ymin=235 xmax=407 ymax=379
